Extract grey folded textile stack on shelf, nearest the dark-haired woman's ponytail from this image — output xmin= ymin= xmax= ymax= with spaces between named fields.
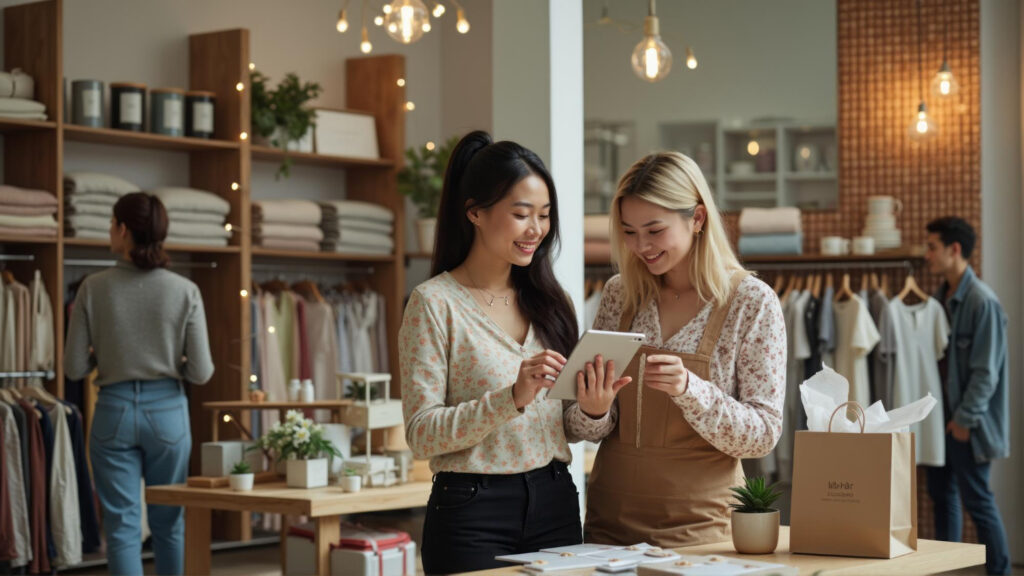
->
xmin=321 ymin=200 xmax=394 ymax=254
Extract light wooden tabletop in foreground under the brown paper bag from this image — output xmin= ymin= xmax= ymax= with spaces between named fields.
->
xmin=472 ymin=526 xmax=985 ymax=576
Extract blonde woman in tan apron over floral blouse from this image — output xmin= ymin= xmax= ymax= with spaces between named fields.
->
xmin=565 ymin=152 xmax=786 ymax=546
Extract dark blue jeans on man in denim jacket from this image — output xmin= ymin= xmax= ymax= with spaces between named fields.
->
xmin=928 ymin=434 xmax=1010 ymax=574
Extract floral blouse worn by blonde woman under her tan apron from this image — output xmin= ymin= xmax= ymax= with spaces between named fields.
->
xmin=565 ymin=276 xmax=786 ymax=458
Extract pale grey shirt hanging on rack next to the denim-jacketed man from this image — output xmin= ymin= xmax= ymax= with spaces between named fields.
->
xmin=889 ymin=298 xmax=949 ymax=466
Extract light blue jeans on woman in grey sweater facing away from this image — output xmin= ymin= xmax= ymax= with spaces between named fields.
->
xmin=89 ymin=380 xmax=191 ymax=576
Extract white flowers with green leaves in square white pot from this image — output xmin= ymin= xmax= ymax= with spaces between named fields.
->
xmin=257 ymin=410 xmax=341 ymax=488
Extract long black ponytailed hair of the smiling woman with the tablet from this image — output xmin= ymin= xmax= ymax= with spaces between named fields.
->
xmin=431 ymin=130 xmax=580 ymax=356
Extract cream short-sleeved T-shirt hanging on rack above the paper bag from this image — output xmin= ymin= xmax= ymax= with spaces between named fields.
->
xmin=833 ymin=295 xmax=879 ymax=408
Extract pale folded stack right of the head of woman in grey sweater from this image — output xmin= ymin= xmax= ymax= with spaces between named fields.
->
xmin=150 ymin=188 xmax=231 ymax=246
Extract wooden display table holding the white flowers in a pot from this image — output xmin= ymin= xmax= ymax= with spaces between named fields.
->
xmin=145 ymin=482 xmax=431 ymax=576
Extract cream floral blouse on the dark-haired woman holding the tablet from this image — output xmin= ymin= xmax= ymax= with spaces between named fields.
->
xmin=398 ymin=273 xmax=571 ymax=474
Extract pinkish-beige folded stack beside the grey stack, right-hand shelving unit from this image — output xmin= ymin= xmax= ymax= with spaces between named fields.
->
xmin=253 ymin=200 xmax=324 ymax=252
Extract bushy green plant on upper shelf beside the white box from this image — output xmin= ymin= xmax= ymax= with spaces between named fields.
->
xmin=249 ymin=70 xmax=323 ymax=178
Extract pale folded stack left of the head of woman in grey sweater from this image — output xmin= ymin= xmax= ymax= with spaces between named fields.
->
xmin=63 ymin=172 xmax=139 ymax=240
